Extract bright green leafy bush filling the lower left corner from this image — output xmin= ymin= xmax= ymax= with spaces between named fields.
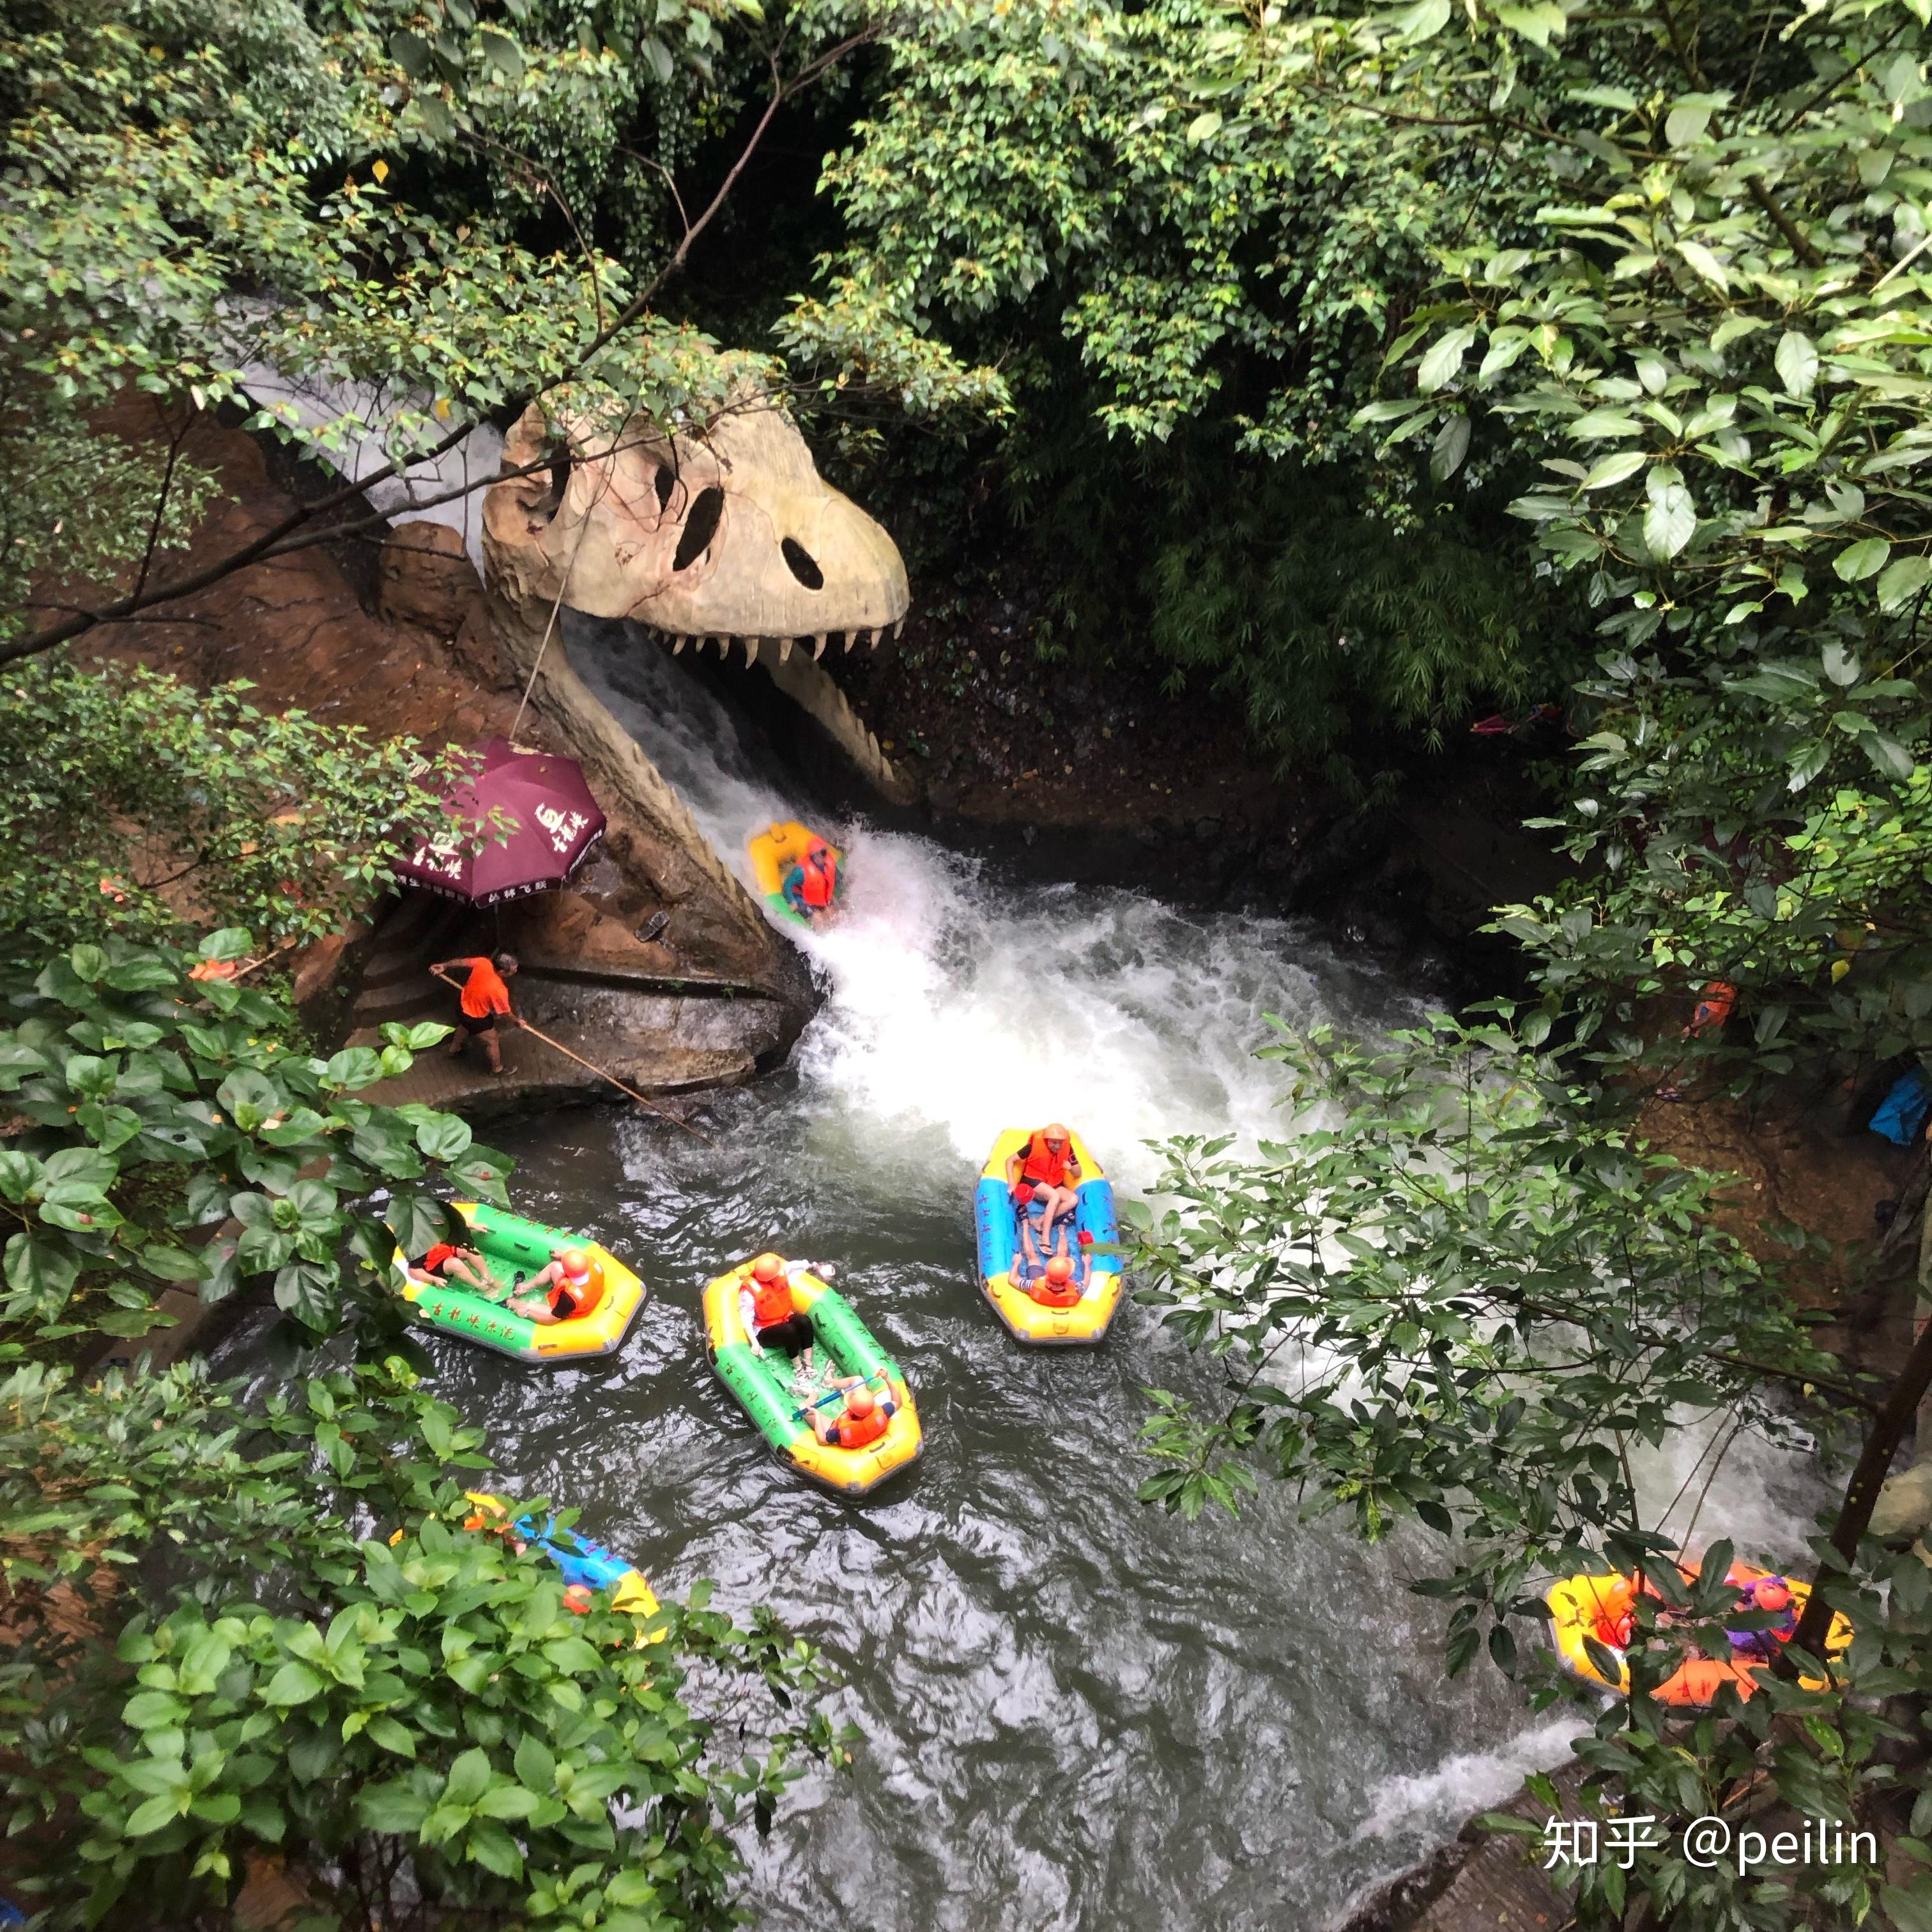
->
xmin=0 ymin=1360 xmax=842 ymax=1932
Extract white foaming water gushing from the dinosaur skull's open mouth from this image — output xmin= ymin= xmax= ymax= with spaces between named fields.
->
xmin=570 ymin=620 xmax=1399 ymax=1183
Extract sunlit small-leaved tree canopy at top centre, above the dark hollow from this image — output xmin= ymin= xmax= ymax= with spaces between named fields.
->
xmin=783 ymin=0 xmax=1482 ymax=450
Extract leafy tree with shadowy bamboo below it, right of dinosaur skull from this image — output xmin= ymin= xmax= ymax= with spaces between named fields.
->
xmin=781 ymin=0 xmax=1575 ymax=763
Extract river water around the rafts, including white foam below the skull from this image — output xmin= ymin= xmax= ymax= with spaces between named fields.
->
xmin=369 ymin=624 xmax=1816 ymax=1932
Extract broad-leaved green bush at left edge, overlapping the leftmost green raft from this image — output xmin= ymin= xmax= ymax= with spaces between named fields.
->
xmin=0 ymin=930 xmax=508 ymax=1358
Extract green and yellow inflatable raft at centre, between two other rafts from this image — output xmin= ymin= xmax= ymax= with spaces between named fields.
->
xmin=705 ymin=1262 xmax=923 ymax=1496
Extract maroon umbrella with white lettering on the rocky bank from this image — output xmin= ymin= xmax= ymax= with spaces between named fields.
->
xmin=390 ymin=738 xmax=605 ymax=906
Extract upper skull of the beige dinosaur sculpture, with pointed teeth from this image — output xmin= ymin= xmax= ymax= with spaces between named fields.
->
xmin=483 ymin=392 xmax=908 ymax=663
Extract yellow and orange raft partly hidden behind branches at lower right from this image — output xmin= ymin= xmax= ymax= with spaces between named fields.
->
xmin=1544 ymin=1563 xmax=1851 ymax=1710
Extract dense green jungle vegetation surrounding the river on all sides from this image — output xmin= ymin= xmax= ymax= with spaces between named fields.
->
xmin=15 ymin=0 xmax=1932 ymax=1932
